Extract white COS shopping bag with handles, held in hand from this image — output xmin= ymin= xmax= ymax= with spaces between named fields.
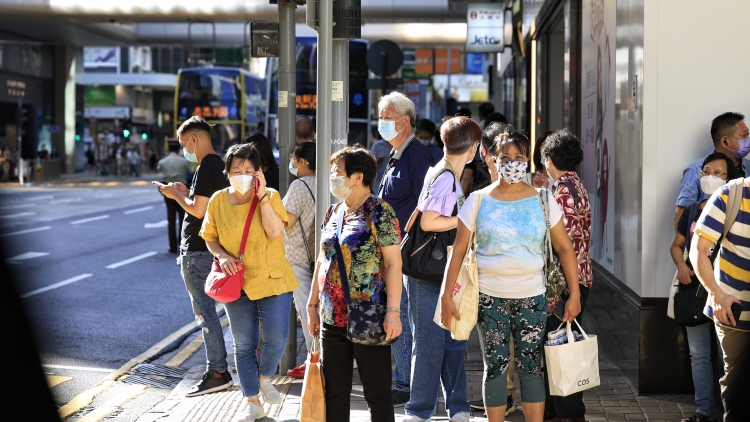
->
xmin=544 ymin=320 xmax=599 ymax=397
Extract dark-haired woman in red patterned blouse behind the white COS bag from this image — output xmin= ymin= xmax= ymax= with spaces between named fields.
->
xmin=541 ymin=129 xmax=591 ymax=422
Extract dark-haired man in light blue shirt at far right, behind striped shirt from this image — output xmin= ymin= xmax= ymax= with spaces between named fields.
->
xmin=674 ymin=112 xmax=750 ymax=230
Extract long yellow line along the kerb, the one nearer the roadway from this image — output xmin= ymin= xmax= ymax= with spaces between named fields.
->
xmin=58 ymin=321 xmax=200 ymax=419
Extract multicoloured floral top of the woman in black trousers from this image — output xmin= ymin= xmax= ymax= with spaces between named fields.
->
xmin=318 ymin=195 xmax=401 ymax=327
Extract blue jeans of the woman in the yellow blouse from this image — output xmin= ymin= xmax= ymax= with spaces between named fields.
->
xmin=224 ymin=291 xmax=292 ymax=397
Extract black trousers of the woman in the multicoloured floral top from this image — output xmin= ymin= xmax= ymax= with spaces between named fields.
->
xmin=320 ymin=323 xmax=395 ymax=422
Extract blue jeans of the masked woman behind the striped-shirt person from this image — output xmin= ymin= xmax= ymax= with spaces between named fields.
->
xmin=685 ymin=323 xmax=721 ymax=416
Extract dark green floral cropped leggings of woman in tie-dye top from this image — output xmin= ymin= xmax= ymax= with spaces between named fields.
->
xmin=477 ymin=293 xmax=547 ymax=407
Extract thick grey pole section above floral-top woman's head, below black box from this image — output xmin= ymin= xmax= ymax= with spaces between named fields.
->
xmin=331 ymin=39 xmax=349 ymax=153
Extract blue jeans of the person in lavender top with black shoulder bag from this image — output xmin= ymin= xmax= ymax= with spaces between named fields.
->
xmin=404 ymin=278 xmax=471 ymax=419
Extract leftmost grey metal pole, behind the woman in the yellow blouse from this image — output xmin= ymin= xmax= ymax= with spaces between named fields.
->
xmin=279 ymin=0 xmax=298 ymax=375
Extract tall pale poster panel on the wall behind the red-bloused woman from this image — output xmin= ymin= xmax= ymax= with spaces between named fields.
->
xmin=581 ymin=0 xmax=617 ymax=272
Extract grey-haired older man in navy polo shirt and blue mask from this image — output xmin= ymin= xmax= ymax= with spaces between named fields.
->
xmin=378 ymin=92 xmax=435 ymax=407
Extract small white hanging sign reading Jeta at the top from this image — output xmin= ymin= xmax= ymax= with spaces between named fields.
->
xmin=466 ymin=3 xmax=505 ymax=53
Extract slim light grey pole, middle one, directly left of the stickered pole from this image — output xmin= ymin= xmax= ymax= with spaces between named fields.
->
xmin=315 ymin=0 xmax=333 ymax=256
